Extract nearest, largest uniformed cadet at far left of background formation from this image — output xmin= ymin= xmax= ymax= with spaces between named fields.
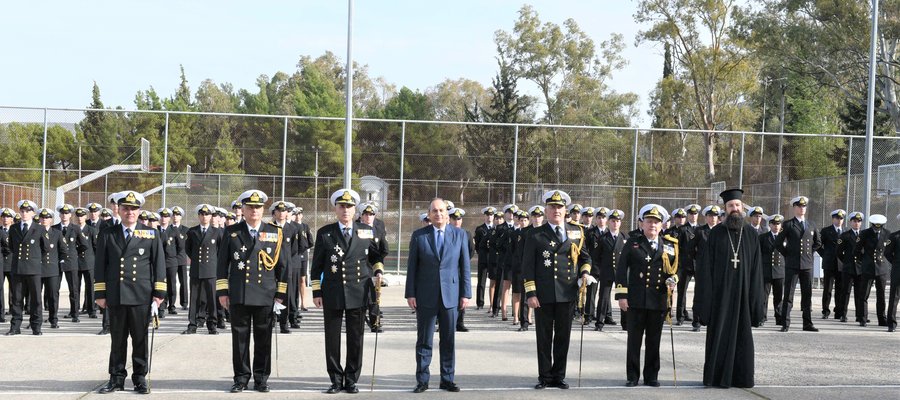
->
xmin=6 ymin=200 xmax=43 ymax=335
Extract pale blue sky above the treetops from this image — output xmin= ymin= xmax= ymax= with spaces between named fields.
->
xmin=0 ymin=0 xmax=662 ymax=126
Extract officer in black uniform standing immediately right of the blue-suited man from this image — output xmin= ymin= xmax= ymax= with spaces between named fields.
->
xmin=522 ymin=190 xmax=593 ymax=389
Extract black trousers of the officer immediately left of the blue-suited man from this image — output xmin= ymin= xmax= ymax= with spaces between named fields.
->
xmin=323 ymin=307 xmax=366 ymax=387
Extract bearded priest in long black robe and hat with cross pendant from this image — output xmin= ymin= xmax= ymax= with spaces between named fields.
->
xmin=698 ymin=189 xmax=766 ymax=388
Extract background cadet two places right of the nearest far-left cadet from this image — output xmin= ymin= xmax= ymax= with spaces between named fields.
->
xmin=53 ymin=204 xmax=87 ymax=322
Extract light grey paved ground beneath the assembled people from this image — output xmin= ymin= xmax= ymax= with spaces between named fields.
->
xmin=0 ymin=280 xmax=900 ymax=400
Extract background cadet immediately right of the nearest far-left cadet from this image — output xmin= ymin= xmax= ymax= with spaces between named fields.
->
xmin=37 ymin=208 xmax=69 ymax=329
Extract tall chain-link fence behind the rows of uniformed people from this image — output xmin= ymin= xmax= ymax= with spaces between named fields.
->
xmin=0 ymin=107 xmax=900 ymax=268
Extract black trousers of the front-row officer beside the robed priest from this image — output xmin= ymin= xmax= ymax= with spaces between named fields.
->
xmin=625 ymin=308 xmax=666 ymax=382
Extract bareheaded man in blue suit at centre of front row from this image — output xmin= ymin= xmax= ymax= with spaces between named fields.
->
xmin=406 ymin=198 xmax=472 ymax=393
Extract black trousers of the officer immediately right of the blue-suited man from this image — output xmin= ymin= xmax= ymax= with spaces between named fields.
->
xmin=534 ymin=301 xmax=575 ymax=383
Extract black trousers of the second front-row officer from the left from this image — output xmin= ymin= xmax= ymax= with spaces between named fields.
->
xmin=230 ymin=304 xmax=274 ymax=385
